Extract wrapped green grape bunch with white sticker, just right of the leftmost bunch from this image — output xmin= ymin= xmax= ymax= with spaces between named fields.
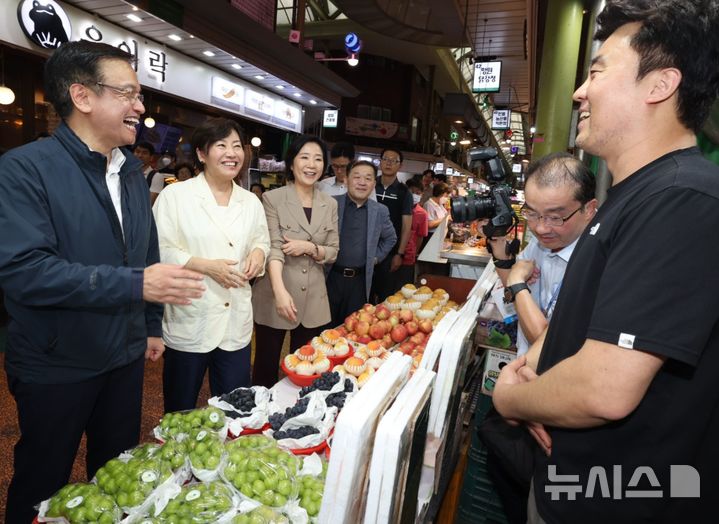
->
xmin=95 ymin=457 xmax=178 ymax=515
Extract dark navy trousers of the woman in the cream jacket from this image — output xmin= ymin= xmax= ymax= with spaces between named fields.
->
xmin=162 ymin=344 xmax=251 ymax=413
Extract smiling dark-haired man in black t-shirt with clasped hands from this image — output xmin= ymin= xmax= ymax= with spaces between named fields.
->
xmin=494 ymin=0 xmax=719 ymax=524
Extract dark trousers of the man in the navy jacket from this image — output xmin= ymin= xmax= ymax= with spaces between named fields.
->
xmin=5 ymin=358 xmax=144 ymax=524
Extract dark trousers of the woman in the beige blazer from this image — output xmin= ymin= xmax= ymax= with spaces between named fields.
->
xmin=252 ymin=324 xmax=323 ymax=388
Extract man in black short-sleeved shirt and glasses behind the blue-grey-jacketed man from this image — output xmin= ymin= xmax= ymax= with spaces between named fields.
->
xmin=372 ymin=149 xmax=414 ymax=302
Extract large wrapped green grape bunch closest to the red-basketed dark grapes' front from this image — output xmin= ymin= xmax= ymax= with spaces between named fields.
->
xmin=225 ymin=436 xmax=299 ymax=508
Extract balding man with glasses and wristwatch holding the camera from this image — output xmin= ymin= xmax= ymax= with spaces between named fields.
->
xmin=490 ymin=153 xmax=597 ymax=355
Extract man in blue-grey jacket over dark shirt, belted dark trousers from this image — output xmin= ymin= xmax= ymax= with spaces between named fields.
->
xmin=327 ymin=160 xmax=397 ymax=326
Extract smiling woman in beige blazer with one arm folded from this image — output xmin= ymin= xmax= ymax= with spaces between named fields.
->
xmin=252 ymin=135 xmax=339 ymax=387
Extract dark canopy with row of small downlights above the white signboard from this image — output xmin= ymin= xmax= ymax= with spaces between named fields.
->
xmin=63 ymin=0 xmax=358 ymax=107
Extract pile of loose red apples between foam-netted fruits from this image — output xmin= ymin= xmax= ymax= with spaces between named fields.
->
xmin=338 ymin=304 xmax=433 ymax=354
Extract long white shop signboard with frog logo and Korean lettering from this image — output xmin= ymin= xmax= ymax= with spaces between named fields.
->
xmin=0 ymin=0 xmax=303 ymax=133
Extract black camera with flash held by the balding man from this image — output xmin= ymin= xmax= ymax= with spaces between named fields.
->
xmin=451 ymin=147 xmax=519 ymax=238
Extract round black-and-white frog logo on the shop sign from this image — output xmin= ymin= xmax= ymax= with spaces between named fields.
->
xmin=17 ymin=0 xmax=72 ymax=49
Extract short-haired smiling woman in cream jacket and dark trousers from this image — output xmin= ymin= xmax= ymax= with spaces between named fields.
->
xmin=153 ymin=118 xmax=270 ymax=412
